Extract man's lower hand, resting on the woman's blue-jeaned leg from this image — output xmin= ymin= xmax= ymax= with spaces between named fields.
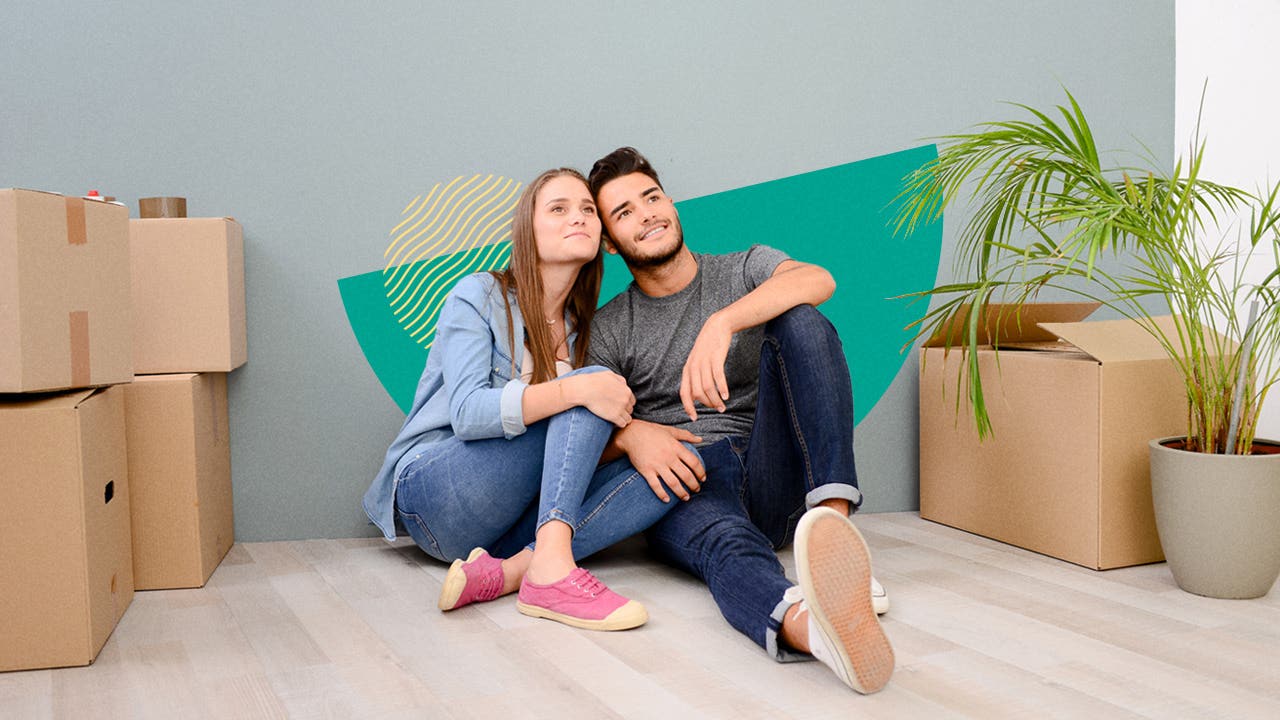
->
xmin=614 ymin=420 xmax=707 ymax=502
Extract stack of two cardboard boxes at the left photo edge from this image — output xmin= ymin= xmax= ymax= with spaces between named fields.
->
xmin=0 ymin=190 xmax=133 ymax=670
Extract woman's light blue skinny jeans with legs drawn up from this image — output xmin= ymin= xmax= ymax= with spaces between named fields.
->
xmin=396 ymin=369 xmax=673 ymax=561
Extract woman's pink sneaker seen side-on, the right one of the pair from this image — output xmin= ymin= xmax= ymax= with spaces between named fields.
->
xmin=516 ymin=568 xmax=649 ymax=630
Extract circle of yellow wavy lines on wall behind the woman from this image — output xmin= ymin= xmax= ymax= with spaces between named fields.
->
xmin=383 ymin=173 xmax=521 ymax=348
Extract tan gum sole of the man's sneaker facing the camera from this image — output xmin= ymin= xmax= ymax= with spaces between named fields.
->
xmin=797 ymin=512 xmax=893 ymax=693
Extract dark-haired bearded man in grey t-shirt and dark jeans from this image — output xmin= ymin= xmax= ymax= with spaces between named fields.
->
xmin=589 ymin=147 xmax=893 ymax=693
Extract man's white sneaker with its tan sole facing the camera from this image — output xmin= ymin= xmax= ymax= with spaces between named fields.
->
xmin=787 ymin=507 xmax=893 ymax=693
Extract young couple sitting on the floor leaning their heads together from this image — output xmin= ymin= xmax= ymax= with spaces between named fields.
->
xmin=364 ymin=147 xmax=893 ymax=693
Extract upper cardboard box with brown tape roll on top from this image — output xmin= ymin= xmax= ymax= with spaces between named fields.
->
xmin=129 ymin=218 xmax=247 ymax=375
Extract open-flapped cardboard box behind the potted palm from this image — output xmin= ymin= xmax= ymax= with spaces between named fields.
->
xmin=920 ymin=304 xmax=1187 ymax=570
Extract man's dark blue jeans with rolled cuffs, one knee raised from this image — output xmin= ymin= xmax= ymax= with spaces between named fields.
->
xmin=648 ymin=305 xmax=861 ymax=661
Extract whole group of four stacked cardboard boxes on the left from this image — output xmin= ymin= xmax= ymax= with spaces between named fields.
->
xmin=0 ymin=190 xmax=246 ymax=671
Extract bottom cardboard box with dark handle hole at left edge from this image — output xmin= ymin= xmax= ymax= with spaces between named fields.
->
xmin=0 ymin=386 xmax=133 ymax=671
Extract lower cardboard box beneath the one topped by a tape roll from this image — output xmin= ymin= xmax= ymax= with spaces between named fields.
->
xmin=123 ymin=373 xmax=236 ymax=589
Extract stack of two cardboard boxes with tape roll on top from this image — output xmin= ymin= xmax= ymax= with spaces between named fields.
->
xmin=124 ymin=218 xmax=247 ymax=589
